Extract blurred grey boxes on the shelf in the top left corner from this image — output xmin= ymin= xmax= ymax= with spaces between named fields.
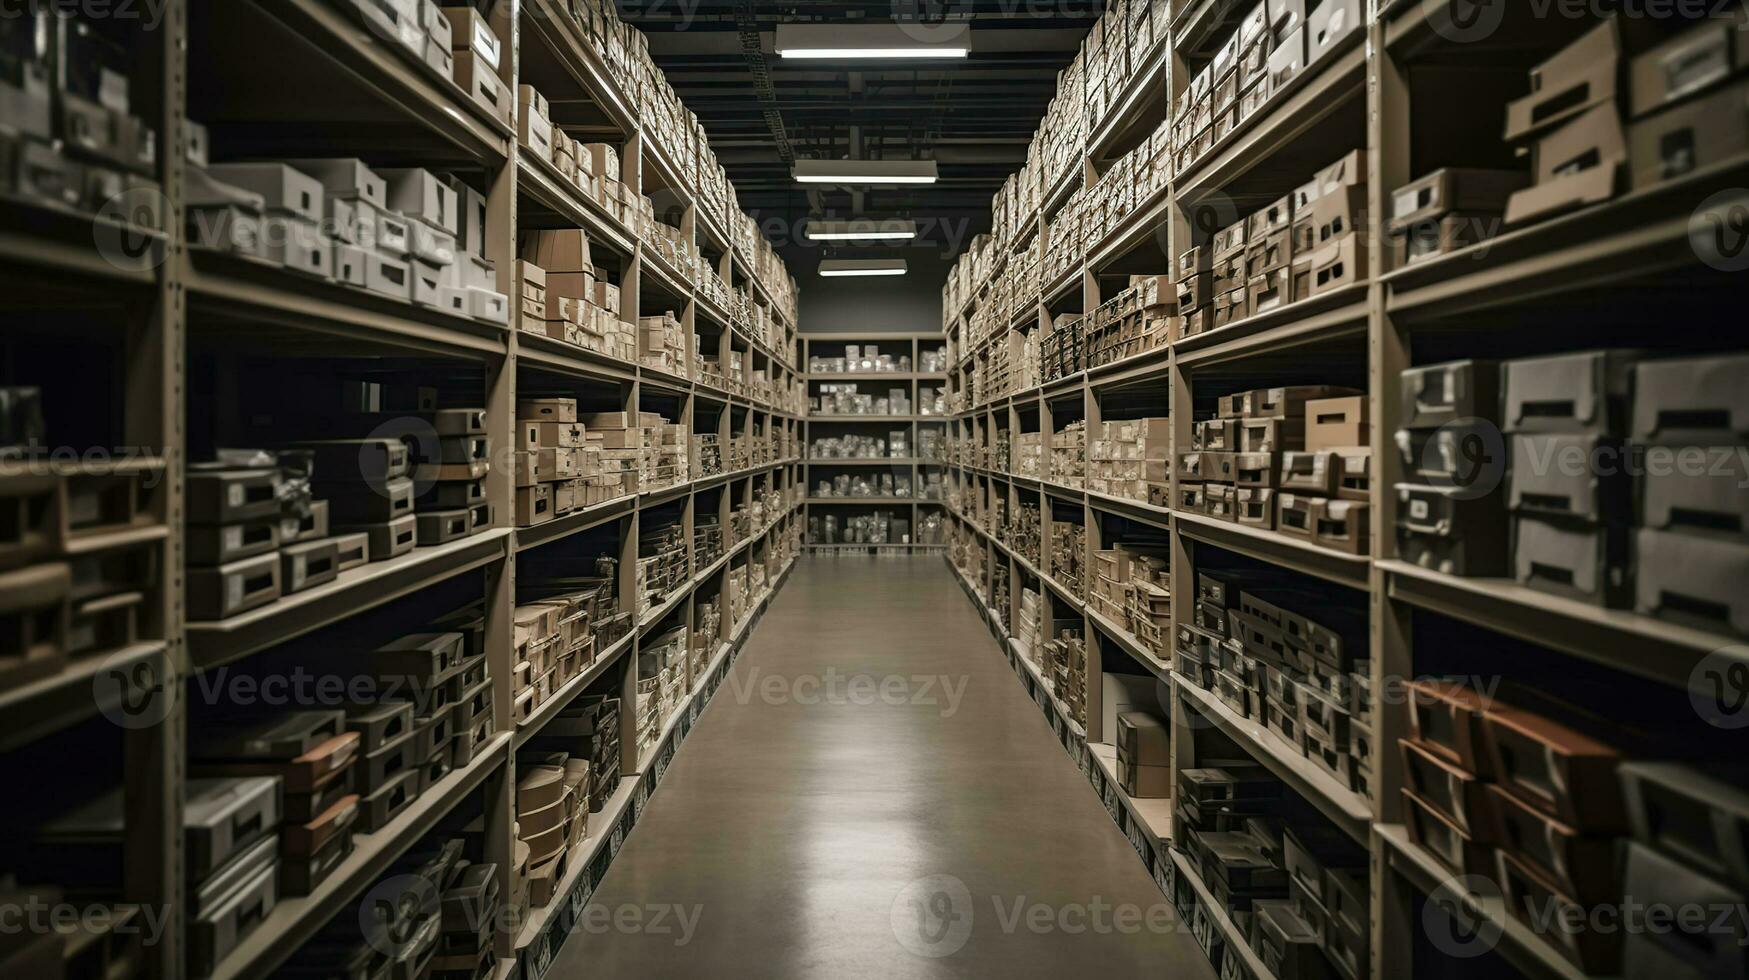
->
xmin=0 ymin=5 xmax=166 ymax=233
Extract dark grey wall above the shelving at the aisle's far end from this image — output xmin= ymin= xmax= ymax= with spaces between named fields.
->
xmin=784 ymin=247 xmax=953 ymax=334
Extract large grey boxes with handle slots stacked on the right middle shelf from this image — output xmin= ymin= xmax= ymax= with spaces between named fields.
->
xmin=1396 ymin=350 xmax=1749 ymax=634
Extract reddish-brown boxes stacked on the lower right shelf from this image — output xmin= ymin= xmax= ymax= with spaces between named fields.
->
xmin=1399 ymin=681 xmax=1665 ymax=977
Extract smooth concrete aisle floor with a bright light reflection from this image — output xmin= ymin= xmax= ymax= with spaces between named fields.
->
xmin=551 ymin=557 xmax=1214 ymax=980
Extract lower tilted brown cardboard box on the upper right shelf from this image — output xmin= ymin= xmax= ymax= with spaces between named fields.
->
xmin=1506 ymin=102 xmax=1628 ymax=226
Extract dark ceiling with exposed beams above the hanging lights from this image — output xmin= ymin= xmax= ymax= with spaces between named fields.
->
xmin=619 ymin=0 xmax=1100 ymax=241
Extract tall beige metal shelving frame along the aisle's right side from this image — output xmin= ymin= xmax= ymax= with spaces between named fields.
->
xmin=943 ymin=0 xmax=1749 ymax=980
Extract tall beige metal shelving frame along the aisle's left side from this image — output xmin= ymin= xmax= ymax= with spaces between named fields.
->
xmin=0 ymin=0 xmax=801 ymax=980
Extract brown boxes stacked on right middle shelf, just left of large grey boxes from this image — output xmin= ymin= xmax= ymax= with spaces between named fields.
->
xmin=1177 ymin=385 xmax=1371 ymax=555
